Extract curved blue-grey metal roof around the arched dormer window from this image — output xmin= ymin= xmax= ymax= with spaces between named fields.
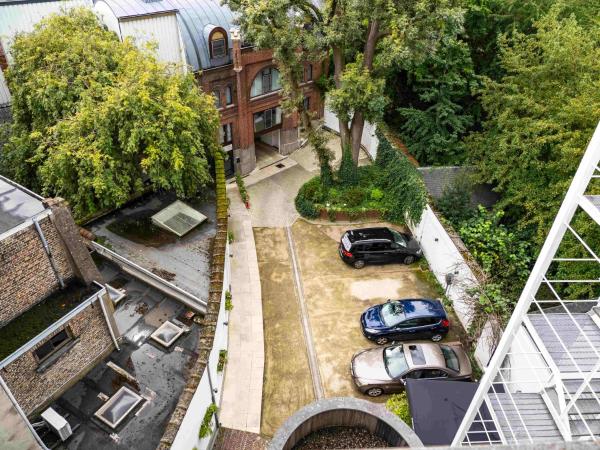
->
xmin=96 ymin=0 xmax=235 ymax=71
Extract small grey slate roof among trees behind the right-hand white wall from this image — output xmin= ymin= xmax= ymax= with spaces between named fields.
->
xmin=418 ymin=166 xmax=499 ymax=208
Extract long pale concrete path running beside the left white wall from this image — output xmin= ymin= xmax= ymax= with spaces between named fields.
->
xmin=220 ymin=184 xmax=265 ymax=433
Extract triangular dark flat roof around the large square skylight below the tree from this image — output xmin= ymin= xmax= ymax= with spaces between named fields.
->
xmin=87 ymin=192 xmax=216 ymax=301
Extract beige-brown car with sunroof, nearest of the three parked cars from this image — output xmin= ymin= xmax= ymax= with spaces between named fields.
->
xmin=350 ymin=343 xmax=472 ymax=397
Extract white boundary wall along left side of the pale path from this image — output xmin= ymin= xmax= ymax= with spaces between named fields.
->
xmin=171 ymin=243 xmax=231 ymax=450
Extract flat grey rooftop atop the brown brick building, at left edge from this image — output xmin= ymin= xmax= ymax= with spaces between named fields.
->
xmin=0 ymin=176 xmax=46 ymax=234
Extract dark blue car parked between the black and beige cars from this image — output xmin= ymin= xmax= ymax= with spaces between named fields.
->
xmin=360 ymin=299 xmax=450 ymax=345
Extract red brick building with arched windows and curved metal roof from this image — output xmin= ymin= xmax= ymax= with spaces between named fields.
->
xmin=94 ymin=0 xmax=323 ymax=174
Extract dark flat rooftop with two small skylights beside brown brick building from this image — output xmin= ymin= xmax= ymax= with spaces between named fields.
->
xmin=32 ymin=257 xmax=200 ymax=450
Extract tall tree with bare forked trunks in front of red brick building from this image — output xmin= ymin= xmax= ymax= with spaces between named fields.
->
xmin=225 ymin=0 xmax=462 ymax=164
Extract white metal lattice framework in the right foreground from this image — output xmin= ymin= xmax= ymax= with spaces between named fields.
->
xmin=452 ymin=124 xmax=600 ymax=446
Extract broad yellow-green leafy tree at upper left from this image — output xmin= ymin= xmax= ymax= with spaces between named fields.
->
xmin=0 ymin=9 xmax=219 ymax=216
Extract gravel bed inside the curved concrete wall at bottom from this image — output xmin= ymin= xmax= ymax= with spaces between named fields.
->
xmin=293 ymin=427 xmax=390 ymax=450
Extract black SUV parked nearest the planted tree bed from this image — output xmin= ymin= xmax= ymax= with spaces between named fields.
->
xmin=339 ymin=228 xmax=422 ymax=269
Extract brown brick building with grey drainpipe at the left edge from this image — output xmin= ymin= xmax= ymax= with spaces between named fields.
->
xmin=0 ymin=177 xmax=117 ymax=415
